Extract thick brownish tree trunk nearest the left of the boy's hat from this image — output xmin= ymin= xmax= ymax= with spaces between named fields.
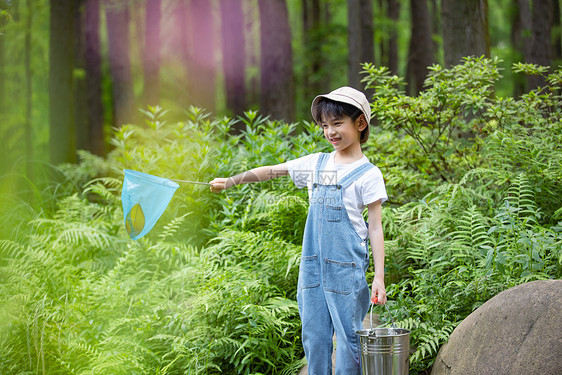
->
xmin=258 ymin=0 xmax=295 ymax=121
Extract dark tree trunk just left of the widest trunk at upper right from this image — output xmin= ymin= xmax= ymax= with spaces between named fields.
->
xmin=408 ymin=0 xmax=434 ymax=95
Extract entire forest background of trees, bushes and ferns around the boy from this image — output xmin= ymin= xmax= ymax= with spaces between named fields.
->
xmin=0 ymin=0 xmax=562 ymax=374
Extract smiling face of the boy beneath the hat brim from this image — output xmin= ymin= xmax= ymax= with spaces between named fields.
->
xmin=320 ymin=114 xmax=365 ymax=151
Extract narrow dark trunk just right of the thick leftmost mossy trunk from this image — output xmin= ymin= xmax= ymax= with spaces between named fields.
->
xmin=84 ymin=0 xmax=105 ymax=156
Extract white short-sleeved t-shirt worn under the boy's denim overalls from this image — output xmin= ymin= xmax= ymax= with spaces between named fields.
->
xmin=287 ymin=151 xmax=388 ymax=240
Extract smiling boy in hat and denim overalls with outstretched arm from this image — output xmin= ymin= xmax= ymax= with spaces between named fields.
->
xmin=210 ymin=87 xmax=387 ymax=375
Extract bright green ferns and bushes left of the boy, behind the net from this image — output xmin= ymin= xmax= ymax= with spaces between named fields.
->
xmin=0 ymin=107 xmax=319 ymax=374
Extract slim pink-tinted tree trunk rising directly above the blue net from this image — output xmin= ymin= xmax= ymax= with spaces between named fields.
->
xmin=143 ymin=0 xmax=161 ymax=105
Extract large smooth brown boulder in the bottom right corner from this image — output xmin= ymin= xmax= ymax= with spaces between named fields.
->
xmin=431 ymin=280 xmax=562 ymax=375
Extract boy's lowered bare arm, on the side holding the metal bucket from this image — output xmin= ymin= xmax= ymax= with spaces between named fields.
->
xmin=367 ymin=200 xmax=386 ymax=305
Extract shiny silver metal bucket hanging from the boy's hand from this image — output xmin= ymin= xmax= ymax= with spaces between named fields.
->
xmin=356 ymin=328 xmax=410 ymax=375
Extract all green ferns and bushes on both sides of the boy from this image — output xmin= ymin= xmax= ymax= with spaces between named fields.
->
xmin=0 ymin=59 xmax=562 ymax=375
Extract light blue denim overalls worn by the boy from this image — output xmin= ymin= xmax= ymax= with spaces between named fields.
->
xmin=297 ymin=154 xmax=373 ymax=375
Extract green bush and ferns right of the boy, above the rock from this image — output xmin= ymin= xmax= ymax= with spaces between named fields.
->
xmin=365 ymin=59 xmax=562 ymax=373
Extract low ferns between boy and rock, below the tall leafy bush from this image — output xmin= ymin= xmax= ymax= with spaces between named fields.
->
xmin=381 ymin=168 xmax=562 ymax=372
